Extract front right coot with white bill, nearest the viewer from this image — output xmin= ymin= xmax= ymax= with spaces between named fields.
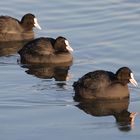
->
xmin=73 ymin=67 xmax=138 ymax=99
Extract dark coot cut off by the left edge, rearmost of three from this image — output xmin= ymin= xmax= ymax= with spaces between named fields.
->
xmin=0 ymin=13 xmax=41 ymax=41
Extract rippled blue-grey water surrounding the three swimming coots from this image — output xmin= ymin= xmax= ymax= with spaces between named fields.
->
xmin=0 ymin=0 xmax=140 ymax=140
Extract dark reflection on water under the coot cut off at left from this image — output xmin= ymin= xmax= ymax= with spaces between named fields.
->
xmin=0 ymin=41 xmax=28 ymax=56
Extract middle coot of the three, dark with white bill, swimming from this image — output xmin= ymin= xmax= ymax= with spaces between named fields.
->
xmin=18 ymin=36 xmax=73 ymax=64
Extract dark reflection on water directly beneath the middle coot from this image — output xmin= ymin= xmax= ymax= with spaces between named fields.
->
xmin=22 ymin=63 xmax=71 ymax=81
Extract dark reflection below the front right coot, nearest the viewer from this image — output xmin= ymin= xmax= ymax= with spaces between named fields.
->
xmin=75 ymin=99 xmax=137 ymax=131
